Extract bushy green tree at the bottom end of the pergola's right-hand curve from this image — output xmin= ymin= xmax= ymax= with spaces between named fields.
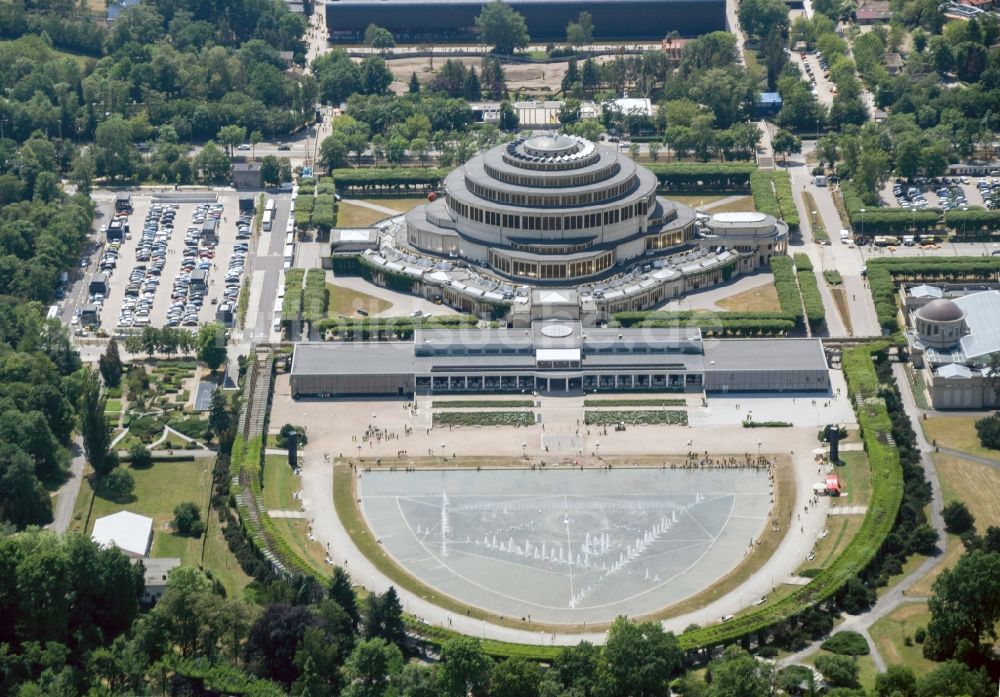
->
xmin=599 ymin=617 xmax=683 ymax=697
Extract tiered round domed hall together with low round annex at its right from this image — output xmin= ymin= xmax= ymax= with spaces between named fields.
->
xmin=406 ymin=135 xmax=787 ymax=285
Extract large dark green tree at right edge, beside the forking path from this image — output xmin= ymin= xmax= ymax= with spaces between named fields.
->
xmin=924 ymin=551 xmax=1000 ymax=665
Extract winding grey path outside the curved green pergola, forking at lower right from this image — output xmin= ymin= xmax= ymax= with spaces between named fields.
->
xmin=778 ymin=363 xmax=948 ymax=673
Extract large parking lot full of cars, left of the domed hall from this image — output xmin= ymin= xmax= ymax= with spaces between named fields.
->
xmin=76 ymin=192 xmax=250 ymax=334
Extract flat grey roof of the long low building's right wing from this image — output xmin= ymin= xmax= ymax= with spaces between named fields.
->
xmin=705 ymin=339 xmax=827 ymax=372
